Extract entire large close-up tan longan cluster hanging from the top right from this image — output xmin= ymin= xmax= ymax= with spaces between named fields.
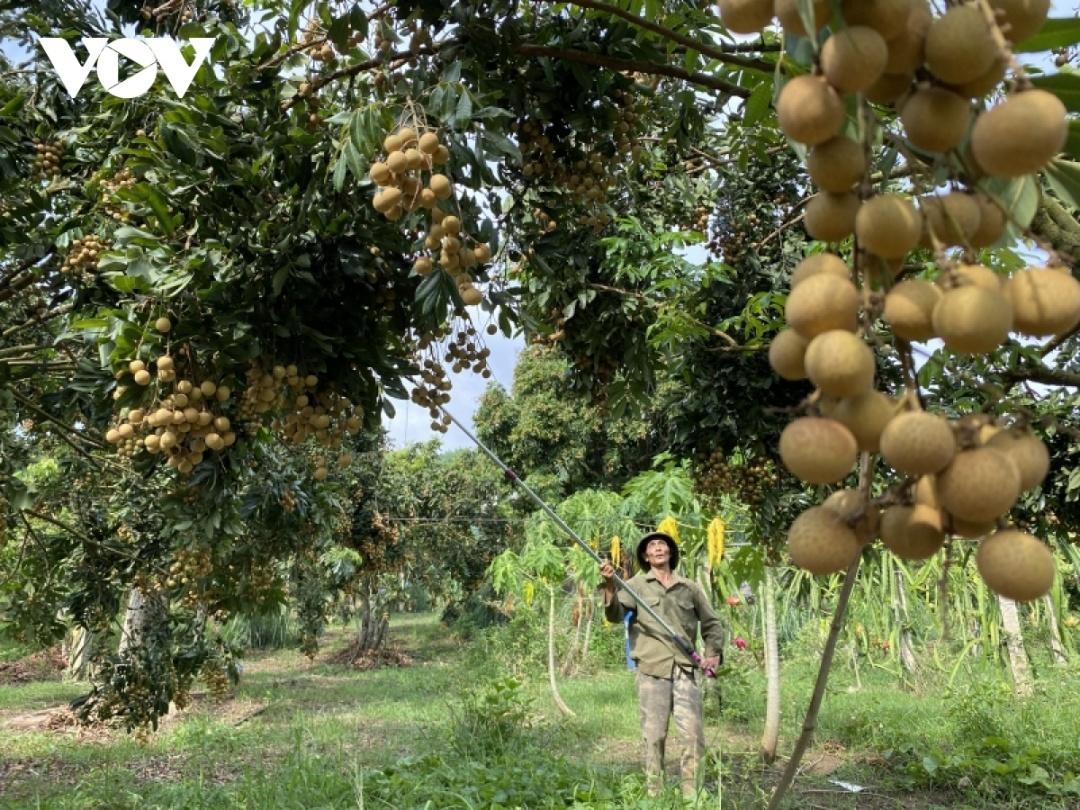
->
xmin=760 ymin=0 xmax=1080 ymax=600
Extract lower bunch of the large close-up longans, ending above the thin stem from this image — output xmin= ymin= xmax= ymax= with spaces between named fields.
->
xmin=769 ymin=247 xmax=1080 ymax=600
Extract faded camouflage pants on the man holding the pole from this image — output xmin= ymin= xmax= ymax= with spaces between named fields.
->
xmin=637 ymin=667 xmax=705 ymax=794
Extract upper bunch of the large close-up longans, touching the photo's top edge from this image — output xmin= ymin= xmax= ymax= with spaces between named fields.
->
xmin=777 ymin=0 xmax=1067 ymax=250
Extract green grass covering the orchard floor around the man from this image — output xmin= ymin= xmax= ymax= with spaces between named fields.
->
xmin=0 ymin=616 xmax=1080 ymax=810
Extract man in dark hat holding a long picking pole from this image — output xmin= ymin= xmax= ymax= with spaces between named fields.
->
xmin=600 ymin=531 xmax=724 ymax=796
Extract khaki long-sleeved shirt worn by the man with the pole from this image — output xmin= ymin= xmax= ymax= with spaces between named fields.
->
xmin=604 ymin=570 xmax=724 ymax=678
